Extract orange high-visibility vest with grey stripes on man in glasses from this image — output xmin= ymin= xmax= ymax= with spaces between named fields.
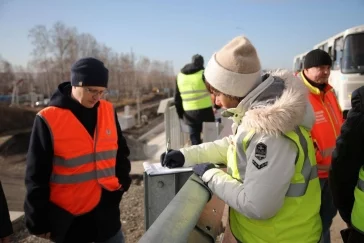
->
xmin=38 ymin=100 xmax=121 ymax=215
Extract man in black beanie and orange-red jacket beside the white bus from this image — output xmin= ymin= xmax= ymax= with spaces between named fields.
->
xmin=298 ymin=49 xmax=343 ymax=243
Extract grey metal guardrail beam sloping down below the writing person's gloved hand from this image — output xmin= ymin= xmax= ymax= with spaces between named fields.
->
xmin=139 ymin=174 xmax=224 ymax=243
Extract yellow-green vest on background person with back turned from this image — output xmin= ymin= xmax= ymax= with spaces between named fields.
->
xmin=177 ymin=70 xmax=212 ymax=111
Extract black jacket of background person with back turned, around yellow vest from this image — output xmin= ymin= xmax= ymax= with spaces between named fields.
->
xmin=174 ymin=63 xmax=215 ymax=125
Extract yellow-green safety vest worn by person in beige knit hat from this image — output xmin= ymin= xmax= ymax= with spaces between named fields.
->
xmin=228 ymin=127 xmax=321 ymax=243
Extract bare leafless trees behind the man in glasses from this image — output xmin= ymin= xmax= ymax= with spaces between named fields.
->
xmin=0 ymin=22 xmax=175 ymax=98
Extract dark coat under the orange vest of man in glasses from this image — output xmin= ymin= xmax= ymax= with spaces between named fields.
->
xmin=24 ymin=82 xmax=131 ymax=243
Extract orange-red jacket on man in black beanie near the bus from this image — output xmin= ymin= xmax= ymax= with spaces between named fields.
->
xmin=300 ymin=72 xmax=344 ymax=178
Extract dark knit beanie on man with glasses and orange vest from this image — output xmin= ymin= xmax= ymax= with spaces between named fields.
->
xmin=71 ymin=57 xmax=109 ymax=88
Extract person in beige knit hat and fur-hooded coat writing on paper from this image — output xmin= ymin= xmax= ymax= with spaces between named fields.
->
xmin=161 ymin=36 xmax=321 ymax=243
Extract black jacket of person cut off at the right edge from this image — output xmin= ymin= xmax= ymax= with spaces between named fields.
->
xmin=329 ymin=86 xmax=364 ymax=242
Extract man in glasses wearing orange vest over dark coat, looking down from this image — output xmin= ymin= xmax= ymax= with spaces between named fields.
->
xmin=24 ymin=58 xmax=131 ymax=243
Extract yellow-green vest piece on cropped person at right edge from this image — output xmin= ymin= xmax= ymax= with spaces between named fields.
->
xmin=351 ymin=167 xmax=364 ymax=234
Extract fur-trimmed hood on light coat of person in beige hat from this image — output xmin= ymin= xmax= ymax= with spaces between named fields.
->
xmin=227 ymin=70 xmax=314 ymax=135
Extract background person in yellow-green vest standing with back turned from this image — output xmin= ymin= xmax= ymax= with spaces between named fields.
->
xmin=174 ymin=54 xmax=215 ymax=145
